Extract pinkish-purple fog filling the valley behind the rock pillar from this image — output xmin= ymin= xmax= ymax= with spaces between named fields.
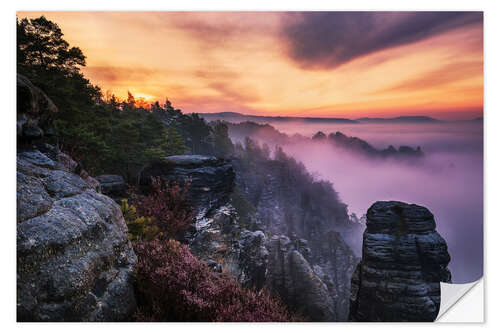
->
xmin=247 ymin=122 xmax=483 ymax=283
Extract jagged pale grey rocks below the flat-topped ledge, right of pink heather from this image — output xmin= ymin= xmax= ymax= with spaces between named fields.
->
xmin=189 ymin=204 xmax=348 ymax=321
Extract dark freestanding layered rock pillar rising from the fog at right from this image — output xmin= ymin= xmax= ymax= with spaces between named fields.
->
xmin=349 ymin=201 xmax=451 ymax=321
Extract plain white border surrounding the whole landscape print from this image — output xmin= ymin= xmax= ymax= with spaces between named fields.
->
xmin=0 ymin=0 xmax=500 ymax=333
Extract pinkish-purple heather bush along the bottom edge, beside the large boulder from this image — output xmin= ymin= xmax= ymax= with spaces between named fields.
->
xmin=134 ymin=239 xmax=294 ymax=322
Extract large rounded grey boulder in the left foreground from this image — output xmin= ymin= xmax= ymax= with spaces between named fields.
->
xmin=17 ymin=145 xmax=136 ymax=321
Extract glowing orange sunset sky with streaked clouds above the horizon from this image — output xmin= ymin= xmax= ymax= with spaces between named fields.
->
xmin=17 ymin=12 xmax=483 ymax=120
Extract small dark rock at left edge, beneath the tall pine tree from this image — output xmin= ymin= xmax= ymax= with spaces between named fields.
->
xmin=16 ymin=74 xmax=58 ymax=142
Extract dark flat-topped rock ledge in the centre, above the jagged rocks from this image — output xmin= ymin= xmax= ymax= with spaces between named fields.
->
xmin=140 ymin=155 xmax=235 ymax=218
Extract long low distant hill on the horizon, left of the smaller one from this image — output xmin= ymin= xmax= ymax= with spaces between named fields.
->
xmin=199 ymin=112 xmax=358 ymax=124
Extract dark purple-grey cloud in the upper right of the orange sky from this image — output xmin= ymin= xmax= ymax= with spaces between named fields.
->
xmin=282 ymin=12 xmax=483 ymax=69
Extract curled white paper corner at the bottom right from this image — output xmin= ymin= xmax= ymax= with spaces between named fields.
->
xmin=436 ymin=278 xmax=484 ymax=323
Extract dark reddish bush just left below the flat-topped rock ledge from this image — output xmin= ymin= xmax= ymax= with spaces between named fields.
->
xmin=130 ymin=177 xmax=193 ymax=239
